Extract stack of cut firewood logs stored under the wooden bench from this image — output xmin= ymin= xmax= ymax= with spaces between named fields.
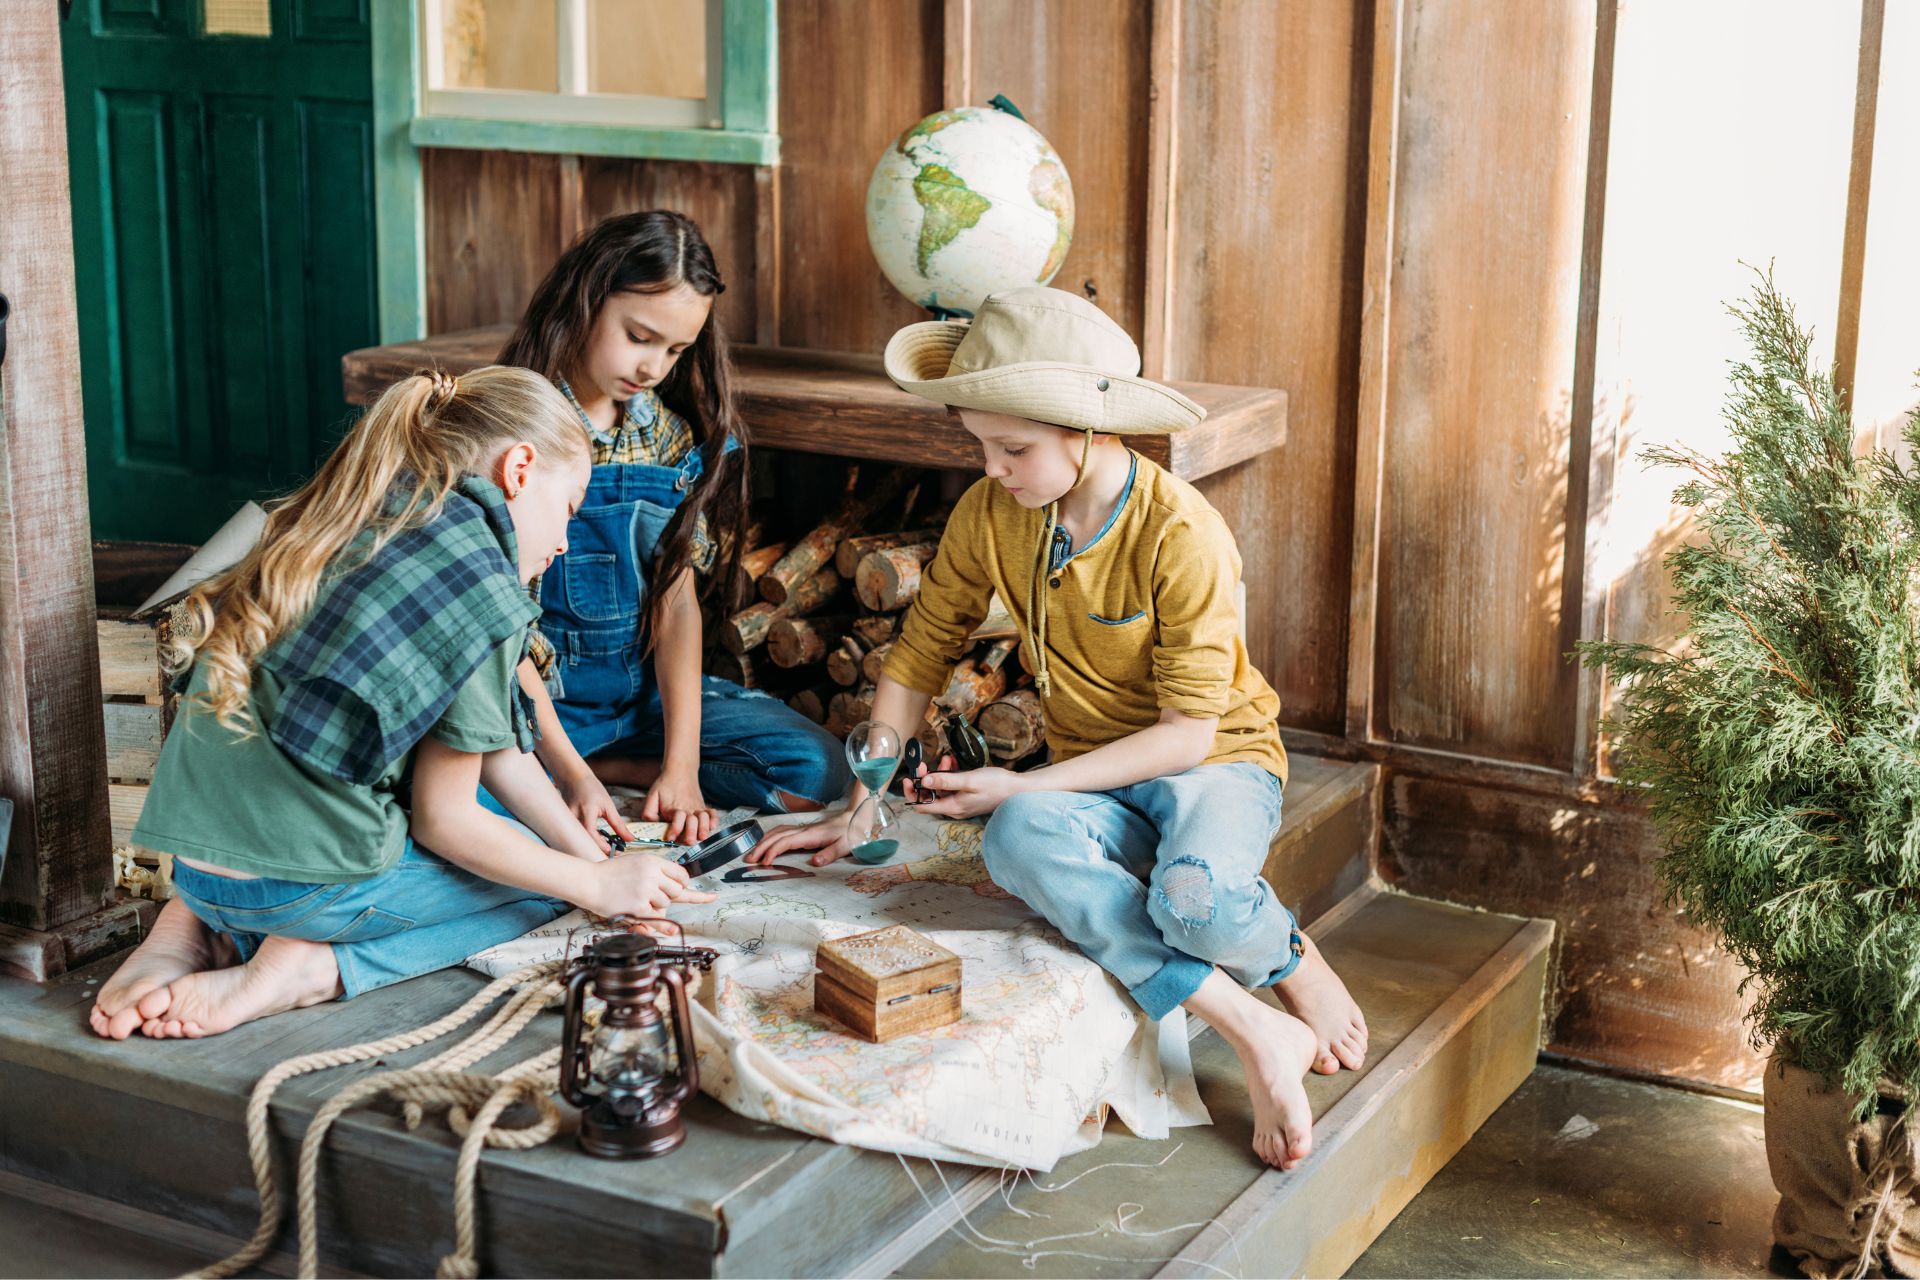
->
xmin=707 ymin=468 xmax=1044 ymax=764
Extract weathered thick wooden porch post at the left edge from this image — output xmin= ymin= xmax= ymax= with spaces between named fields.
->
xmin=0 ymin=4 xmax=113 ymax=929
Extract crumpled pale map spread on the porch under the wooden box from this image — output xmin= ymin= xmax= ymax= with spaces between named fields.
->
xmin=467 ymin=812 xmax=1210 ymax=1169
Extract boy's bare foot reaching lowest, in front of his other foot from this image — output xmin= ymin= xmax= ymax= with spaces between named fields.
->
xmin=1187 ymin=969 xmax=1317 ymax=1169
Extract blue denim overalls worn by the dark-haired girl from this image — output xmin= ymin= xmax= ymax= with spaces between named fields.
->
xmin=540 ymin=426 xmax=852 ymax=812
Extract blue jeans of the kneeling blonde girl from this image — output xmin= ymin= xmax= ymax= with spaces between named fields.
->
xmin=173 ymin=823 xmax=568 ymax=1000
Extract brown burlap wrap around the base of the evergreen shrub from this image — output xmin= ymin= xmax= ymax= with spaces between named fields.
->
xmin=1764 ymin=1054 xmax=1920 ymax=1280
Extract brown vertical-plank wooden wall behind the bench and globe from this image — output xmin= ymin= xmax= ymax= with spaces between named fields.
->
xmin=412 ymin=0 xmax=1920 ymax=1086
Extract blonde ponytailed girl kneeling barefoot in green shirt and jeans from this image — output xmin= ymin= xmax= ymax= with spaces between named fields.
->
xmin=92 ymin=368 xmax=705 ymax=1038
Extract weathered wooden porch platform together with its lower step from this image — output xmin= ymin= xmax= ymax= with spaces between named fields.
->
xmin=0 ymin=758 xmax=1548 ymax=1276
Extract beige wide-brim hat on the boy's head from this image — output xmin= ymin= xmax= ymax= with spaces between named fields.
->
xmin=885 ymin=286 xmax=1206 ymax=436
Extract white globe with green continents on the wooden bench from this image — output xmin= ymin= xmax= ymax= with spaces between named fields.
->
xmin=866 ymin=106 xmax=1073 ymax=315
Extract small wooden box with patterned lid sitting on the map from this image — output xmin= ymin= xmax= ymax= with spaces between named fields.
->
xmin=814 ymin=925 xmax=960 ymax=1044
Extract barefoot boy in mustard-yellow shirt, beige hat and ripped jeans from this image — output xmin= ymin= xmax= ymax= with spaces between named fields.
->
xmin=751 ymin=288 xmax=1367 ymax=1169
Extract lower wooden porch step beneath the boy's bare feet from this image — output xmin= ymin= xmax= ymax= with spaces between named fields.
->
xmin=890 ymin=887 xmax=1553 ymax=1276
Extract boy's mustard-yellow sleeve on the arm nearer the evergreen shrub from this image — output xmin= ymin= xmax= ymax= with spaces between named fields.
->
xmin=1154 ymin=512 xmax=1240 ymax=716
